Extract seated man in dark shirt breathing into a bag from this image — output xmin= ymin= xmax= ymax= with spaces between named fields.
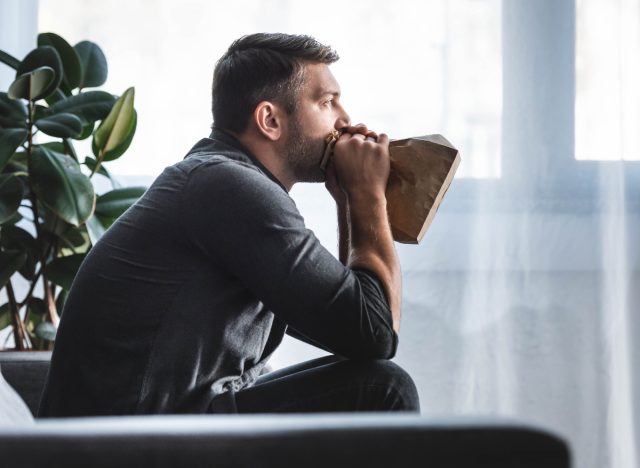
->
xmin=39 ymin=34 xmax=419 ymax=416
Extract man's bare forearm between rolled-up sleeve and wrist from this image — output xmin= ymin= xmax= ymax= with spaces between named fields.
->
xmin=347 ymin=193 xmax=402 ymax=332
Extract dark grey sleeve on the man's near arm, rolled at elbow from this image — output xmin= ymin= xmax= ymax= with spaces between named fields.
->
xmin=181 ymin=161 xmax=398 ymax=359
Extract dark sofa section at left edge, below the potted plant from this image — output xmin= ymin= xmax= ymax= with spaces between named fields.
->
xmin=0 ymin=351 xmax=51 ymax=415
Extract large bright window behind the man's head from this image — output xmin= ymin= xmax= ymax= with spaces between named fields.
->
xmin=39 ymin=0 xmax=502 ymax=178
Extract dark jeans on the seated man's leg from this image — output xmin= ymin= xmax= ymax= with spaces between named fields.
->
xmin=219 ymin=356 xmax=420 ymax=413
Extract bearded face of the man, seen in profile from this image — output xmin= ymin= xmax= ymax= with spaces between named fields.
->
xmin=285 ymin=64 xmax=350 ymax=182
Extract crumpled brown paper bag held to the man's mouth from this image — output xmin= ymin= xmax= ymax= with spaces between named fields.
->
xmin=386 ymin=135 xmax=460 ymax=244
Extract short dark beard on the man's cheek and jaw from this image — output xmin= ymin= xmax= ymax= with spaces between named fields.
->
xmin=286 ymin=116 xmax=326 ymax=182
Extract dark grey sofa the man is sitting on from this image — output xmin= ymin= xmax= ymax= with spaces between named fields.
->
xmin=0 ymin=352 xmax=570 ymax=468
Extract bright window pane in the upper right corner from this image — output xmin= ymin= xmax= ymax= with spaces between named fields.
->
xmin=576 ymin=0 xmax=640 ymax=161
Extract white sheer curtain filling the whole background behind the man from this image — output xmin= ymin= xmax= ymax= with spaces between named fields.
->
xmin=12 ymin=0 xmax=640 ymax=468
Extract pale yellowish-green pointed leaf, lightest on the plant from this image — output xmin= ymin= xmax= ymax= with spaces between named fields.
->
xmin=92 ymin=88 xmax=137 ymax=162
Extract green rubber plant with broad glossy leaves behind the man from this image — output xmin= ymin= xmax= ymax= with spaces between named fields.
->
xmin=0 ymin=33 xmax=145 ymax=350
